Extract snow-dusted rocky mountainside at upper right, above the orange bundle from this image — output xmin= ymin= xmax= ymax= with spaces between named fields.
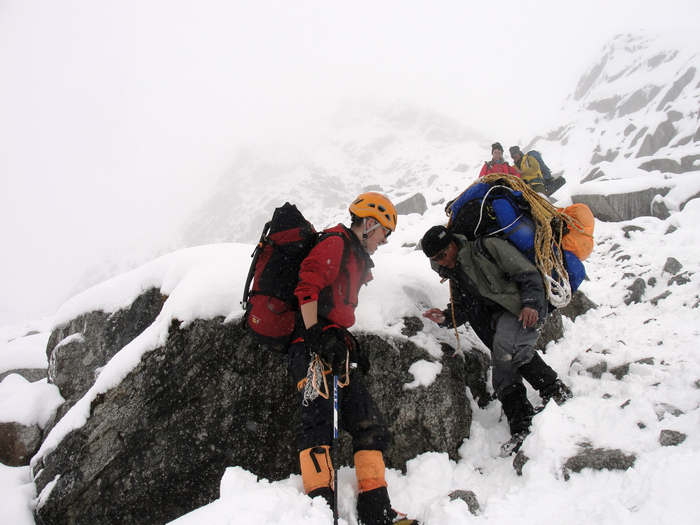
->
xmin=531 ymin=35 xmax=700 ymax=221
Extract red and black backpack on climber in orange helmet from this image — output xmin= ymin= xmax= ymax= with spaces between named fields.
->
xmin=241 ymin=202 xmax=349 ymax=352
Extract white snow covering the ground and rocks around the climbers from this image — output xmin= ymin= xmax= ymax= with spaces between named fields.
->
xmin=0 ymin=33 xmax=700 ymax=525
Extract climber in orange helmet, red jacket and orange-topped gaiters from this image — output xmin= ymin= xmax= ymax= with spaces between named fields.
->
xmin=288 ymin=192 xmax=417 ymax=525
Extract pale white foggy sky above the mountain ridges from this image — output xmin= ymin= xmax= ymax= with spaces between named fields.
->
xmin=0 ymin=0 xmax=700 ymax=326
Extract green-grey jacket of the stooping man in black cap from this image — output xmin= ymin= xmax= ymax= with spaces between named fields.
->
xmin=431 ymin=234 xmax=547 ymax=319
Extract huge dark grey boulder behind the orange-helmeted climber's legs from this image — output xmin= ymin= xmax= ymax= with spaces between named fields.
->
xmin=32 ymin=298 xmax=471 ymax=525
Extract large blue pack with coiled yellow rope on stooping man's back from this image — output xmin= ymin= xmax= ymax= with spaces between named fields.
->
xmin=448 ymin=175 xmax=592 ymax=307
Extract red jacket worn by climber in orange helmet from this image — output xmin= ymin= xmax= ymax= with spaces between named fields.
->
xmin=294 ymin=224 xmax=374 ymax=328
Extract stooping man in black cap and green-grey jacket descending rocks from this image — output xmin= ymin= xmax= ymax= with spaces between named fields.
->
xmin=421 ymin=226 xmax=572 ymax=455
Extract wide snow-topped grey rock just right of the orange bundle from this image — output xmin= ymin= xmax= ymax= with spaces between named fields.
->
xmin=572 ymin=188 xmax=668 ymax=222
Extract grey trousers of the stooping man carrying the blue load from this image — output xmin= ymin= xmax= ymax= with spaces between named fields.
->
xmin=491 ymin=312 xmax=540 ymax=396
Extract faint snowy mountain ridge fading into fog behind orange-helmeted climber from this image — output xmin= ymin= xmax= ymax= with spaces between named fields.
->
xmin=183 ymin=101 xmax=483 ymax=246
